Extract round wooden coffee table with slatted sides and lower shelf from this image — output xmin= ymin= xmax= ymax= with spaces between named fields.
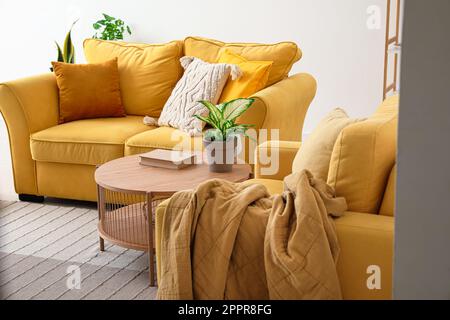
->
xmin=95 ymin=155 xmax=251 ymax=286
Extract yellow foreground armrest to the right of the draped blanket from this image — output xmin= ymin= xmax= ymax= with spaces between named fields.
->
xmin=335 ymin=212 xmax=394 ymax=300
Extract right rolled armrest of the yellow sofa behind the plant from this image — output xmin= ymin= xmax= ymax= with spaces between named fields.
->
xmin=243 ymin=73 xmax=317 ymax=141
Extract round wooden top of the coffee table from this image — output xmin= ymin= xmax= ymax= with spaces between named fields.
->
xmin=95 ymin=155 xmax=251 ymax=193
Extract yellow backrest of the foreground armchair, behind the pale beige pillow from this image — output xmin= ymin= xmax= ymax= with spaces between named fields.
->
xmin=328 ymin=96 xmax=399 ymax=214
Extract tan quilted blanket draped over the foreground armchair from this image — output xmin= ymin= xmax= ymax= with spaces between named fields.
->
xmin=158 ymin=171 xmax=346 ymax=299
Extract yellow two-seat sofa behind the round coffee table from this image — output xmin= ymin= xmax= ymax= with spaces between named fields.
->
xmin=0 ymin=37 xmax=316 ymax=201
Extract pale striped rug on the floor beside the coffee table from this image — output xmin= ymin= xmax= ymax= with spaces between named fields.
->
xmin=0 ymin=201 xmax=156 ymax=299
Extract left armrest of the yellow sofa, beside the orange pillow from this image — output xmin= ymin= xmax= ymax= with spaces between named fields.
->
xmin=0 ymin=73 xmax=58 ymax=195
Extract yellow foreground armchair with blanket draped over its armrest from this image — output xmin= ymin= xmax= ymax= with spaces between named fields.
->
xmin=155 ymin=96 xmax=398 ymax=299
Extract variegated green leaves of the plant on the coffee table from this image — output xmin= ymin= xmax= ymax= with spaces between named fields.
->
xmin=194 ymin=98 xmax=255 ymax=141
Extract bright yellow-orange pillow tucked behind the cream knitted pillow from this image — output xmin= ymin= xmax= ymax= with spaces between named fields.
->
xmin=217 ymin=49 xmax=273 ymax=103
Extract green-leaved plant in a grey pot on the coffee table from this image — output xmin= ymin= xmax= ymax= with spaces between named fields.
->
xmin=194 ymin=98 xmax=254 ymax=172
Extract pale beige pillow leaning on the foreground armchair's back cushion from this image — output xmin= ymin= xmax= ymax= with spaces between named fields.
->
xmin=292 ymin=108 xmax=361 ymax=181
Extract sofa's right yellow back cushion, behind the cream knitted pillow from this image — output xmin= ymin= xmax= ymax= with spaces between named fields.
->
xmin=184 ymin=37 xmax=302 ymax=86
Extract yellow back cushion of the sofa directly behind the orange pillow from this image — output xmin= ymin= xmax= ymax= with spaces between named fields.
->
xmin=84 ymin=39 xmax=183 ymax=117
